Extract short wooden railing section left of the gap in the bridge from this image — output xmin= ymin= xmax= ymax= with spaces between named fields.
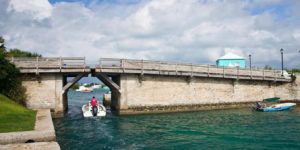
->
xmin=7 ymin=57 xmax=89 ymax=70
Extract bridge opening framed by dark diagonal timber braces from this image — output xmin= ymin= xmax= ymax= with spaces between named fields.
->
xmin=62 ymin=71 xmax=120 ymax=116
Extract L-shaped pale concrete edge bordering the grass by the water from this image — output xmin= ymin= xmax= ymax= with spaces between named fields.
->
xmin=0 ymin=109 xmax=56 ymax=147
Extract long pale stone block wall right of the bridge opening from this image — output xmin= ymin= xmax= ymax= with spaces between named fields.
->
xmin=120 ymin=75 xmax=300 ymax=113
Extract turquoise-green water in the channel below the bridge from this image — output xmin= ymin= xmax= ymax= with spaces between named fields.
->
xmin=54 ymin=90 xmax=300 ymax=150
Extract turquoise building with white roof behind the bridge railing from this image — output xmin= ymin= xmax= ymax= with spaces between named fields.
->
xmin=216 ymin=53 xmax=246 ymax=68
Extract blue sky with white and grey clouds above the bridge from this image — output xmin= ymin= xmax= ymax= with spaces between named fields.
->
xmin=0 ymin=0 xmax=300 ymax=69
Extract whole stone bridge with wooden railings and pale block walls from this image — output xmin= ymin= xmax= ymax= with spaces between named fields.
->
xmin=8 ymin=57 xmax=299 ymax=117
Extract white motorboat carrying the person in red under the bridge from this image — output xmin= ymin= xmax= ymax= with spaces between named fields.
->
xmin=82 ymin=103 xmax=106 ymax=117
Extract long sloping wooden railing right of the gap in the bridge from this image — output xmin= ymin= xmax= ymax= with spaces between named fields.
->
xmin=98 ymin=58 xmax=291 ymax=81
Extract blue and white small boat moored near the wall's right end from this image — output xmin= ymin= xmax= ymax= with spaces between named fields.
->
xmin=255 ymin=102 xmax=296 ymax=112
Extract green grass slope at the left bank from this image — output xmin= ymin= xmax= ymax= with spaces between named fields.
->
xmin=0 ymin=94 xmax=36 ymax=133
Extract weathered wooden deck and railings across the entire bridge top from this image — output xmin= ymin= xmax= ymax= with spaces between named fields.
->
xmin=9 ymin=57 xmax=291 ymax=82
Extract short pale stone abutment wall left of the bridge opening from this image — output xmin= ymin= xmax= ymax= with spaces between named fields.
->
xmin=22 ymin=73 xmax=66 ymax=116
